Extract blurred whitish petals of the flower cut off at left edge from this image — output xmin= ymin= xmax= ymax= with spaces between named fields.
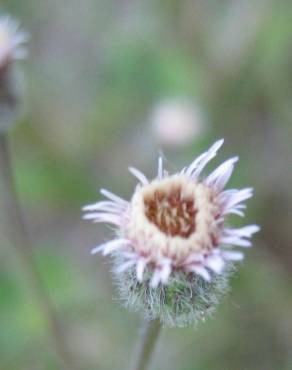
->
xmin=0 ymin=16 xmax=28 ymax=68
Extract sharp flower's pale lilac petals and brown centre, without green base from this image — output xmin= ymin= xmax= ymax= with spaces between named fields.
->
xmin=84 ymin=140 xmax=259 ymax=287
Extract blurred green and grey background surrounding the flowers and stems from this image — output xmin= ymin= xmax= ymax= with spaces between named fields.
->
xmin=0 ymin=0 xmax=292 ymax=370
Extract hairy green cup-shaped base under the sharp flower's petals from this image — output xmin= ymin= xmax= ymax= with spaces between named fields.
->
xmin=114 ymin=256 xmax=234 ymax=327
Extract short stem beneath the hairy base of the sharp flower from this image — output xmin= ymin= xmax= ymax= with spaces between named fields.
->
xmin=131 ymin=320 xmax=162 ymax=370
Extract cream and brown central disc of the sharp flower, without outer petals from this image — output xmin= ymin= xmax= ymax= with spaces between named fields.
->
xmin=125 ymin=174 xmax=220 ymax=265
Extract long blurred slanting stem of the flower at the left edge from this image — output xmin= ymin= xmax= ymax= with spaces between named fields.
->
xmin=0 ymin=133 xmax=75 ymax=370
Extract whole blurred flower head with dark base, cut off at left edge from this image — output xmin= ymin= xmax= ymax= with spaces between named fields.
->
xmin=0 ymin=16 xmax=28 ymax=132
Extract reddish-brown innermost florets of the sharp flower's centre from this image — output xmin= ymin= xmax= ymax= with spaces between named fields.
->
xmin=144 ymin=187 xmax=197 ymax=238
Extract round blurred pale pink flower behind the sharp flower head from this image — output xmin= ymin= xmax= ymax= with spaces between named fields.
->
xmin=151 ymin=98 xmax=203 ymax=146
